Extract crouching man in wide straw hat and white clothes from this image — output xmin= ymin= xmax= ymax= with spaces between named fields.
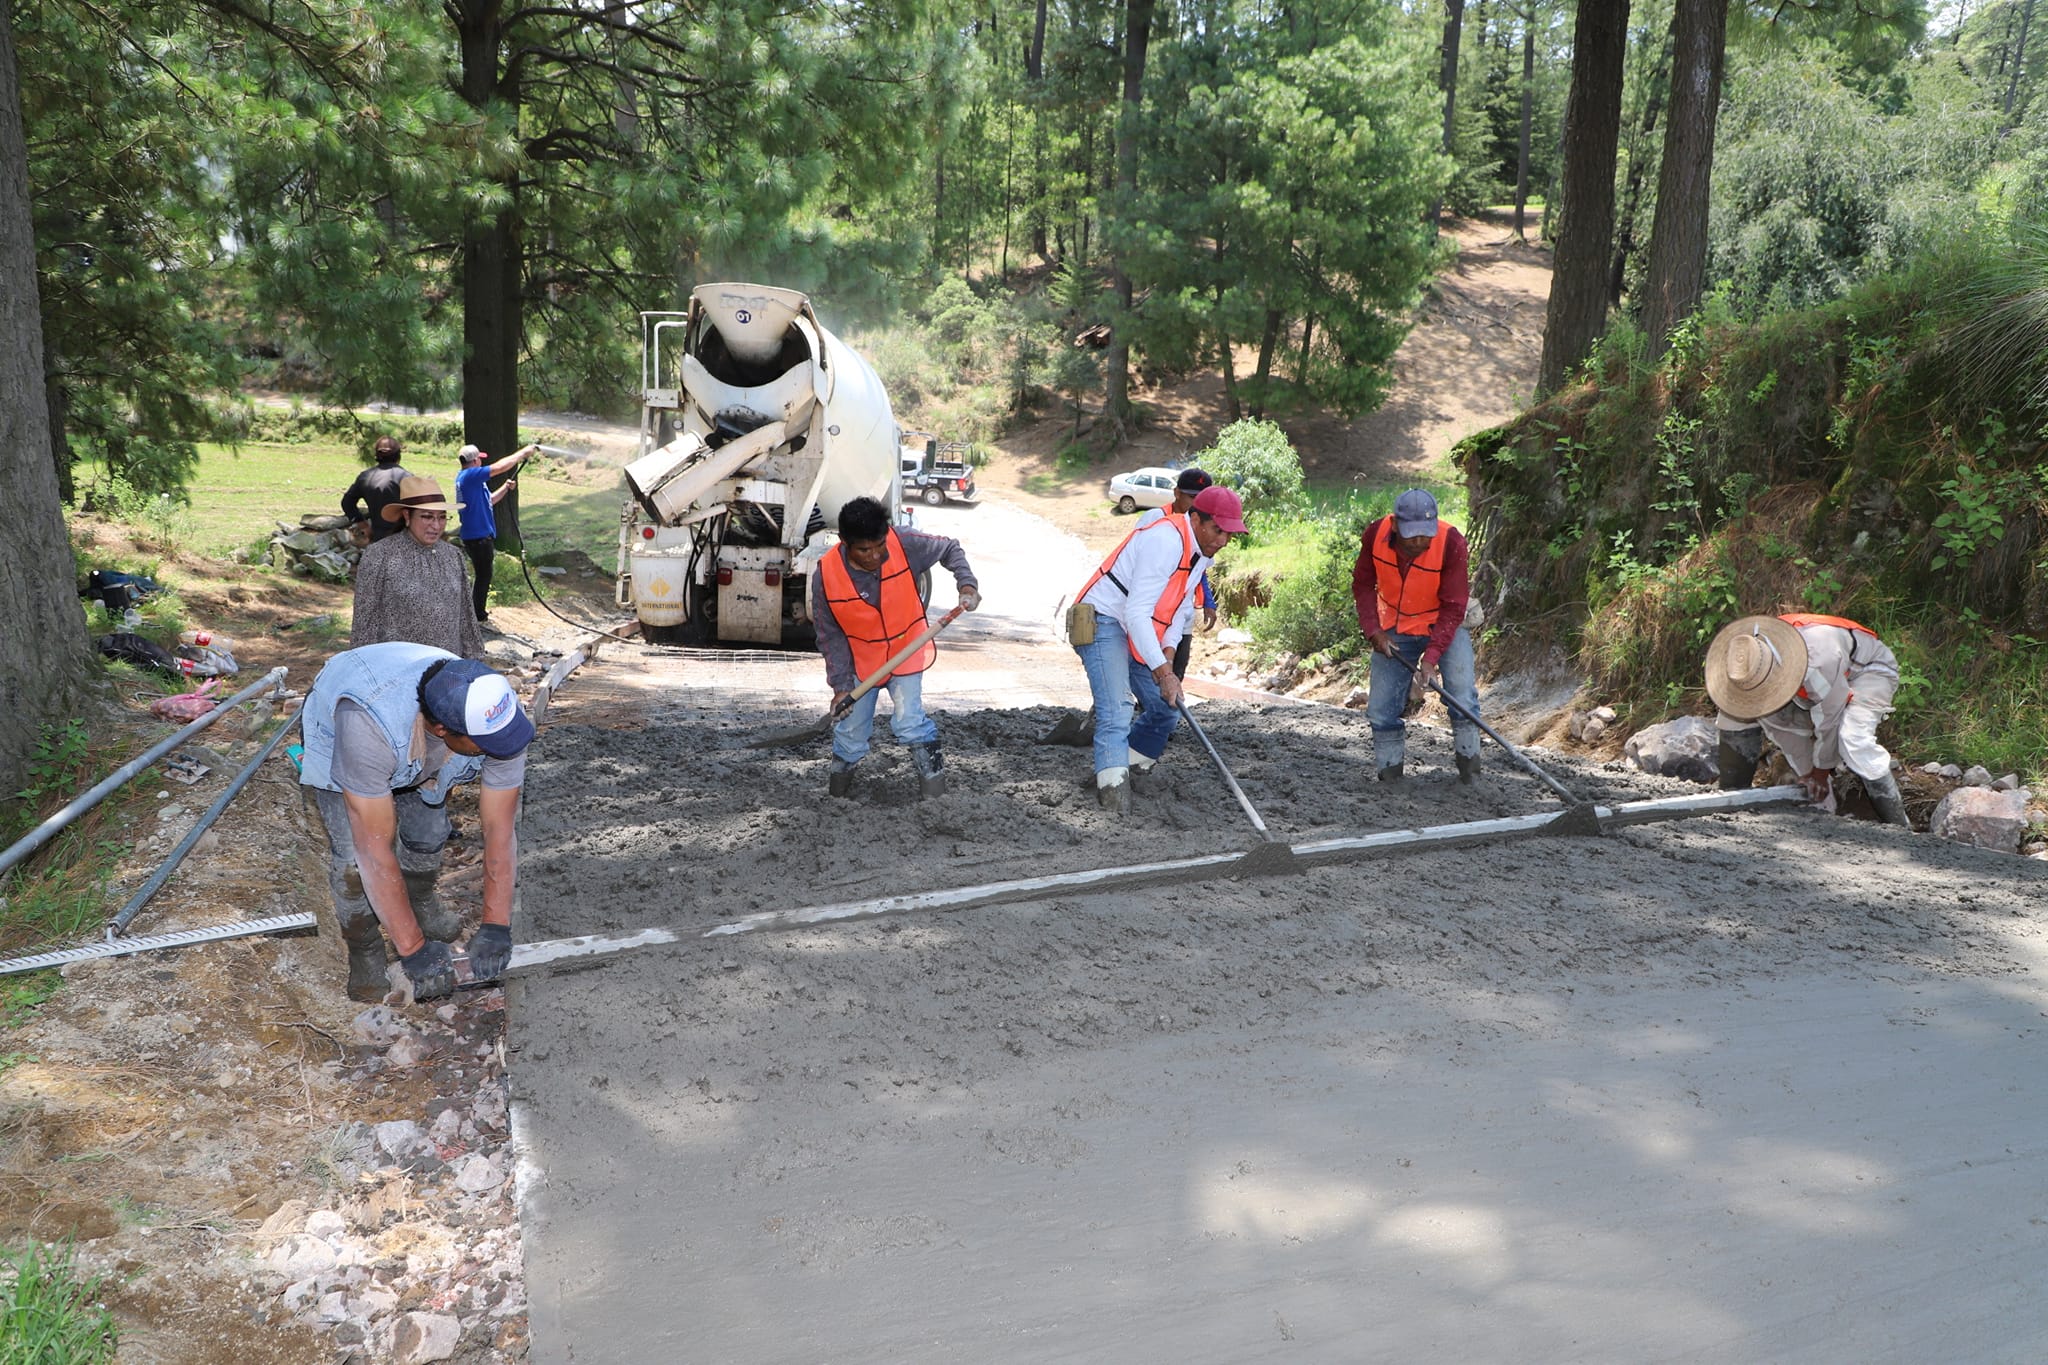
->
xmin=1706 ymin=612 xmax=1913 ymax=829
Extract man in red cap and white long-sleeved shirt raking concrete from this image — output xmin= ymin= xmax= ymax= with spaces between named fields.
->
xmin=1067 ymin=487 xmax=1245 ymax=814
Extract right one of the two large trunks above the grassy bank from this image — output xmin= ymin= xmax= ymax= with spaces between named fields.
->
xmin=1642 ymin=0 xmax=1729 ymax=356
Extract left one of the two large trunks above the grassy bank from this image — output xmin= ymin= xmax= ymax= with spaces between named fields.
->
xmin=1536 ymin=0 xmax=1628 ymax=395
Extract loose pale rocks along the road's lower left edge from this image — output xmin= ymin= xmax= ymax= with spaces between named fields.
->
xmin=250 ymin=993 xmax=526 ymax=1365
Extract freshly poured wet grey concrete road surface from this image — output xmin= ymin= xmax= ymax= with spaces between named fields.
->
xmin=510 ymin=581 xmax=2048 ymax=1363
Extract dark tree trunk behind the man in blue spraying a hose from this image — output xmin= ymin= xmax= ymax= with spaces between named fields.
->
xmin=451 ymin=0 xmax=526 ymax=551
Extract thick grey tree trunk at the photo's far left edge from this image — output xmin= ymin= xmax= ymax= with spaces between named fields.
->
xmin=0 ymin=0 xmax=88 ymax=794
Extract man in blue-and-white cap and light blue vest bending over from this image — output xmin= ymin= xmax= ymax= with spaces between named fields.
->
xmin=299 ymin=643 xmax=532 ymax=1001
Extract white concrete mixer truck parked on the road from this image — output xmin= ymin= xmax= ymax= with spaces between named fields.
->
xmin=616 ymin=284 xmax=903 ymax=647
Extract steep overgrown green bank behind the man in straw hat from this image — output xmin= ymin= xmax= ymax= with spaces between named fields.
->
xmin=1456 ymin=256 xmax=2048 ymax=784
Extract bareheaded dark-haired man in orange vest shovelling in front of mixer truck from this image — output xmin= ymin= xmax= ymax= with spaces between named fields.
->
xmin=811 ymin=497 xmax=981 ymax=796
